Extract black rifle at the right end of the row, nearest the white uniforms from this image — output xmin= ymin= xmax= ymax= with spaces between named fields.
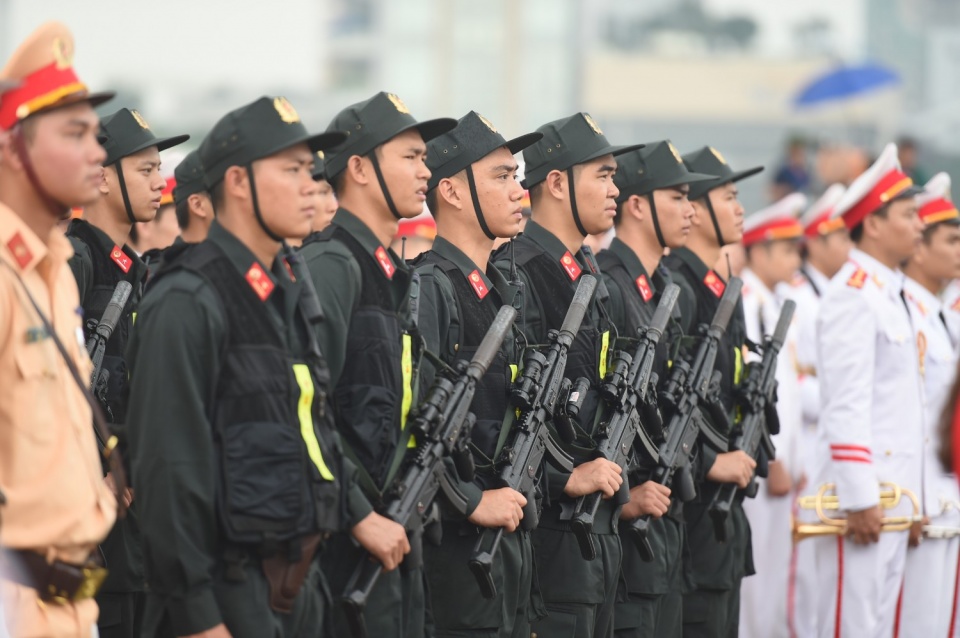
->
xmin=709 ymin=301 xmax=797 ymax=541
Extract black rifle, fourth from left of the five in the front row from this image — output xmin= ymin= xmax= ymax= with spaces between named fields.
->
xmin=630 ymin=277 xmax=743 ymax=562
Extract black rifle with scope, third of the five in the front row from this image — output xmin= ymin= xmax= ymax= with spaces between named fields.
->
xmin=570 ymin=284 xmax=680 ymax=560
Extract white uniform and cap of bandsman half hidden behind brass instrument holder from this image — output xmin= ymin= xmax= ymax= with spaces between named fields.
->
xmin=781 ymin=184 xmax=846 ymax=638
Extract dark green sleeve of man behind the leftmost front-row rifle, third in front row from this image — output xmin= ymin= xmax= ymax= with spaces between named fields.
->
xmin=418 ymin=265 xmax=483 ymax=517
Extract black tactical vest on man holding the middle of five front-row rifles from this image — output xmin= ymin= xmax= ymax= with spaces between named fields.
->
xmin=506 ymin=236 xmax=612 ymax=460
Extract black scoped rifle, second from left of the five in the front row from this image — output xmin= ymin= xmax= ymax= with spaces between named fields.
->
xmin=469 ymin=275 xmax=597 ymax=598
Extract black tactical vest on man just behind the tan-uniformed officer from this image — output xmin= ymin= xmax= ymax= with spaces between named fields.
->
xmin=67 ymin=220 xmax=143 ymax=424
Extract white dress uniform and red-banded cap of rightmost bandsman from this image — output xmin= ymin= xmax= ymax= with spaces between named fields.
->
xmin=899 ymin=178 xmax=960 ymax=636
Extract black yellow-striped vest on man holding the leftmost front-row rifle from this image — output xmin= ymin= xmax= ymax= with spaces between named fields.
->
xmin=304 ymin=224 xmax=421 ymax=492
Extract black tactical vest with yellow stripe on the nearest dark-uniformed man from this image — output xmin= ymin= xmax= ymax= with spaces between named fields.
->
xmin=156 ymin=242 xmax=341 ymax=546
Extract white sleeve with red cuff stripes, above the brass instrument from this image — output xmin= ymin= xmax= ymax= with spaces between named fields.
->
xmin=817 ymin=289 xmax=879 ymax=511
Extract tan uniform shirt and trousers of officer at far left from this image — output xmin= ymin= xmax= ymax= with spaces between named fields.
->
xmin=0 ymin=204 xmax=116 ymax=636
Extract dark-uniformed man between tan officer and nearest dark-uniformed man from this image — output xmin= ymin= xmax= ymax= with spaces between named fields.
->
xmin=67 ymin=109 xmax=189 ymax=638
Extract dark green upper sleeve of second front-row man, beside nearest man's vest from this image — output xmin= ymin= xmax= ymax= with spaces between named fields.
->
xmin=302 ymin=244 xmax=360 ymax=387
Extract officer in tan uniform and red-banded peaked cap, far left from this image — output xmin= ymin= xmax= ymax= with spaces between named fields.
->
xmin=0 ymin=22 xmax=116 ymax=638
